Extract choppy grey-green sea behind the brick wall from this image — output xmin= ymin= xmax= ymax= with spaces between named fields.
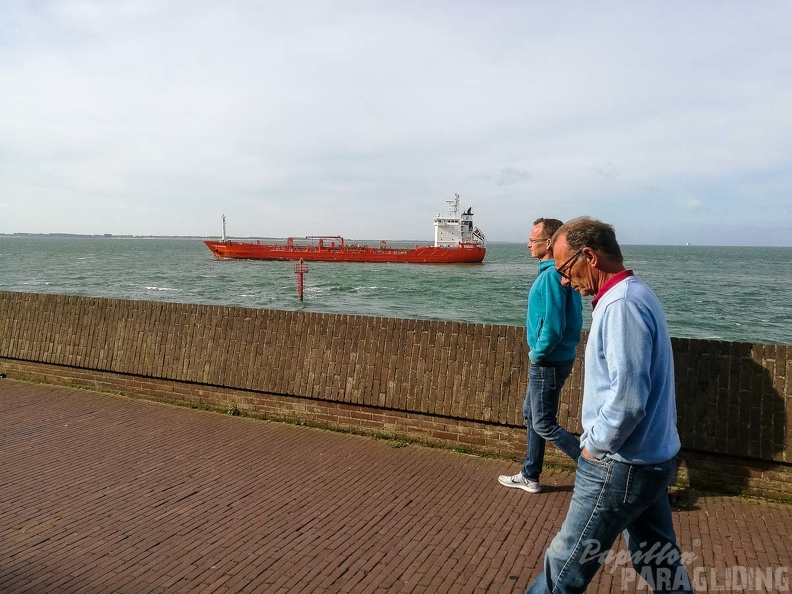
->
xmin=0 ymin=235 xmax=792 ymax=345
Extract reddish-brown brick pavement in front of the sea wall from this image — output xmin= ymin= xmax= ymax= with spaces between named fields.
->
xmin=0 ymin=379 xmax=792 ymax=594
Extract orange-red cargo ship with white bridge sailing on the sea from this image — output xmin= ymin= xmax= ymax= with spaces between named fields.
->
xmin=204 ymin=194 xmax=487 ymax=264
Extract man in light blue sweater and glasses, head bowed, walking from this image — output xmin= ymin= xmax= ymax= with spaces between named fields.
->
xmin=526 ymin=217 xmax=692 ymax=593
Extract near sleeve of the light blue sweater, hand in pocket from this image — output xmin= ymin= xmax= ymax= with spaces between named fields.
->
xmin=583 ymin=299 xmax=654 ymax=458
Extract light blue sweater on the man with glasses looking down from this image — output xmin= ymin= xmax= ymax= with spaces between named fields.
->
xmin=580 ymin=276 xmax=679 ymax=464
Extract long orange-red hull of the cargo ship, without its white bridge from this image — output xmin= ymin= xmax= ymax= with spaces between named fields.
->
xmin=204 ymin=241 xmax=487 ymax=264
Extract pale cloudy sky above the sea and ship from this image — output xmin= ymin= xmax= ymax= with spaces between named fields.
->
xmin=0 ymin=0 xmax=792 ymax=246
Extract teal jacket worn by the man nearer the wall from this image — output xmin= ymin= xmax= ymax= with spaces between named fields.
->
xmin=525 ymin=260 xmax=583 ymax=365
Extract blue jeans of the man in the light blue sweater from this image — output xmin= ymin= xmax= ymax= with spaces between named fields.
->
xmin=526 ymin=456 xmax=693 ymax=594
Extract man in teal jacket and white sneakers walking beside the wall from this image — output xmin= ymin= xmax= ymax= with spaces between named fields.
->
xmin=498 ymin=218 xmax=583 ymax=493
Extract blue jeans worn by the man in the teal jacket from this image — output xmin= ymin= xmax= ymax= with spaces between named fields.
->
xmin=522 ymin=359 xmax=580 ymax=481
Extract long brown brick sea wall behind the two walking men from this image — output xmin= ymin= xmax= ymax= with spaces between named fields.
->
xmin=0 ymin=292 xmax=792 ymax=500
